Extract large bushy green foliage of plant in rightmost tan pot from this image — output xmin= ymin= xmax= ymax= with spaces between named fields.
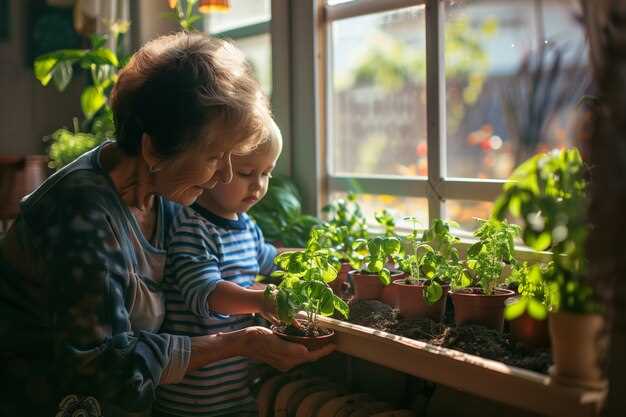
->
xmin=493 ymin=149 xmax=598 ymax=313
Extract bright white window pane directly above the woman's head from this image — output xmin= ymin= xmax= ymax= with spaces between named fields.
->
xmin=204 ymin=0 xmax=272 ymax=33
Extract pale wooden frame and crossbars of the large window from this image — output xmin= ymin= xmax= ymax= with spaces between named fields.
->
xmin=316 ymin=0 xmax=506 ymax=222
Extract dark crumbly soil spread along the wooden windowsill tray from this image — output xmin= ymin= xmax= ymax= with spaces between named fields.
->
xmin=349 ymin=300 xmax=552 ymax=373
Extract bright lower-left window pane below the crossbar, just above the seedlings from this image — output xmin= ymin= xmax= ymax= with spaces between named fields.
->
xmin=329 ymin=191 xmax=428 ymax=228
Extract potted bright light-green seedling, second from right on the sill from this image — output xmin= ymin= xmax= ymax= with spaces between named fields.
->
xmin=504 ymin=262 xmax=555 ymax=348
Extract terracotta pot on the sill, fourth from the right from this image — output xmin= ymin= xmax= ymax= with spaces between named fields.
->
xmin=392 ymin=279 xmax=449 ymax=321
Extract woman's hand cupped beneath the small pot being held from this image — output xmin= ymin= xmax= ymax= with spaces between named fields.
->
xmin=231 ymin=326 xmax=335 ymax=371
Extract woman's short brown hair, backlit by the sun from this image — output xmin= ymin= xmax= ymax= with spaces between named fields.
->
xmin=111 ymin=32 xmax=269 ymax=158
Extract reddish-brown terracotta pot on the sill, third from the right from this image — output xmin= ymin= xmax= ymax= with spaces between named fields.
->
xmin=450 ymin=288 xmax=513 ymax=332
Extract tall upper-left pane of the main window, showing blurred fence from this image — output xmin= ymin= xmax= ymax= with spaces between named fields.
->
xmin=328 ymin=6 xmax=427 ymax=176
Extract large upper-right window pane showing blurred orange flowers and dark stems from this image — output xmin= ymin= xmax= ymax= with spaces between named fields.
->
xmin=445 ymin=0 xmax=590 ymax=178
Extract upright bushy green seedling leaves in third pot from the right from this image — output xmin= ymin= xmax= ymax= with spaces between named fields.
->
xmin=454 ymin=219 xmax=520 ymax=295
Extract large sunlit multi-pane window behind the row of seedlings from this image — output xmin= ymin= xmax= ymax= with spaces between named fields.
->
xmin=321 ymin=0 xmax=590 ymax=230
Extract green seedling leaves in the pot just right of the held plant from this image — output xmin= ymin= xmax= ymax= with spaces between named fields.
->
xmin=352 ymin=236 xmax=401 ymax=285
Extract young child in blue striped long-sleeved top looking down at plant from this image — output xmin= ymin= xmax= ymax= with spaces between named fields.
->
xmin=154 ymin=121 xmax=282 ymax=417
